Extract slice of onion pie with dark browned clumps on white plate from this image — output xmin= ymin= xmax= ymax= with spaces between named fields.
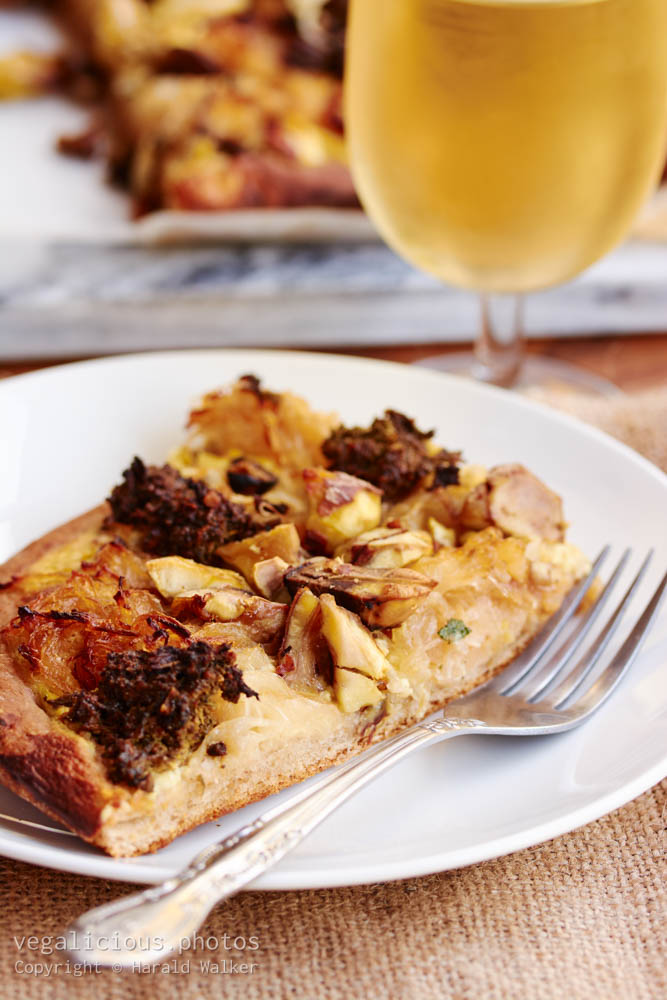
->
xmin=0 ymin=376 xmax=589 ymax=855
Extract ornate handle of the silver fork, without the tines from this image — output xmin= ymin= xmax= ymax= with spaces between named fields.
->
xmin=67 ymin=719 xmax=474 ymax=968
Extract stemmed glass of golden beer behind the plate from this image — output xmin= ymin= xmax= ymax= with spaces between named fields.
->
xmin=345 ymin=0 xmax=667 ymax=385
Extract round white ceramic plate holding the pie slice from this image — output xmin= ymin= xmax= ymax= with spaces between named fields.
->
xmin=0 ymin=351 xmax=667 ymax=889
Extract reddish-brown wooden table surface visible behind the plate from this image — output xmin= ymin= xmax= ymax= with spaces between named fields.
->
xmin=0 ymin=332 xmax=667 ymax=392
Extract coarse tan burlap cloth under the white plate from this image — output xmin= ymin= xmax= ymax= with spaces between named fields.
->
xmin=0 ymin=389 xmax=667 ymax=1000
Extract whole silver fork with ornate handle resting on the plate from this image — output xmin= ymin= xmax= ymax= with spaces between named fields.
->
xmin=67 ymin=546 xmax=667 ymax=968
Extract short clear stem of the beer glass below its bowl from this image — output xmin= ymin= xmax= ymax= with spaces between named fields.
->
xmin=474 ymin=293 xmax=523 ymax=388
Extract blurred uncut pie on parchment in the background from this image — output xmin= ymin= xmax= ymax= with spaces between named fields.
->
xmin=0 ymin=0 xmax=358 ymax=216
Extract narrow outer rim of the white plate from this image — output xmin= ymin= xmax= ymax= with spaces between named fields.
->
xmin=0 ymin=347 xmax=667 ymax=891
